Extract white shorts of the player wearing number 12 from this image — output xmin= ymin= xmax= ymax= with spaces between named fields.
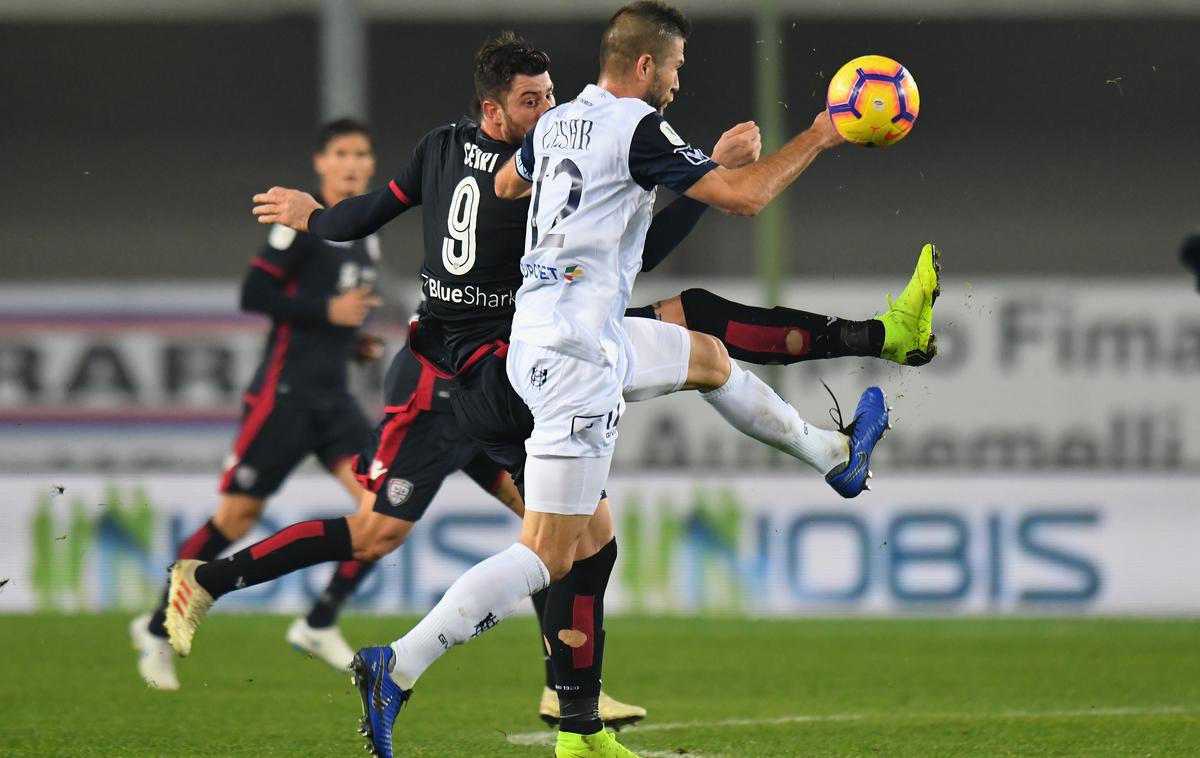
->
xmin=505 ymin=318 xmax=691 ymax=515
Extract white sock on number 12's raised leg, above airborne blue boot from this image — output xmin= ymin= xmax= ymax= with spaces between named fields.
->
xmin=701 ymin=361 xmax=850 ymax=474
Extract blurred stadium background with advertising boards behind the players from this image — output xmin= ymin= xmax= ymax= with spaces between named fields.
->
xmin=0 ymin=0 xmax=1200 ymax=615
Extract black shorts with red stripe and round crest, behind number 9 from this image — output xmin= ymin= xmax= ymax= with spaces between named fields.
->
xmin=354 ymin=403 xmax=504 ymax=522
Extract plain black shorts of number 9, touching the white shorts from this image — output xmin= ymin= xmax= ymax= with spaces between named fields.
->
xmin=450 ymin=351 xmax=533 ymax=489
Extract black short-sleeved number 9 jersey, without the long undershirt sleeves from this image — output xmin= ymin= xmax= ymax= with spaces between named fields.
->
xmin=389 ymin=118 xmax=529 ymax=374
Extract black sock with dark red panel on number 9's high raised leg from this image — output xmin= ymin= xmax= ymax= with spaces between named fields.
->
xmin=679 ymin=289 xmax=883 ymax=366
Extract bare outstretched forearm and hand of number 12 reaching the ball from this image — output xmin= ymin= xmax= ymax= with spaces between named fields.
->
xmin=686 ymin=112 xmax=845 ymax=216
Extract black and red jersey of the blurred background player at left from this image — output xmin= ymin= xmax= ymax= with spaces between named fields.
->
xmin=241 ymin=219 xmax=379 ymax=408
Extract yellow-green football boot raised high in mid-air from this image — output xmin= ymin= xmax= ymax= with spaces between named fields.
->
xmin=876 ymin=243 xmax=942 ymax=366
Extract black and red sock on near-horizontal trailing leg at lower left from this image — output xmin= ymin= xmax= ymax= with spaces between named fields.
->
xmin=196 ymin=518 xmax=353 ymax=597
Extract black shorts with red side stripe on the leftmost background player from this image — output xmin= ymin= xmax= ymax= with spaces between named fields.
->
xmin=221 ymin=395 xmax=371 ymax=499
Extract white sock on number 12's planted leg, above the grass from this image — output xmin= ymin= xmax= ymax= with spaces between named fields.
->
xmin=391 ymin=542 xmax=550 ymax=690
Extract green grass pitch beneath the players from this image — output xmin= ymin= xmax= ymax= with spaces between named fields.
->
xmin=0 ymin=614 xmax=1200 ymax=758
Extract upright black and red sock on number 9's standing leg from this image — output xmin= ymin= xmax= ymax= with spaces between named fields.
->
xmin=542 ymin=540 xmax=617 ymax=734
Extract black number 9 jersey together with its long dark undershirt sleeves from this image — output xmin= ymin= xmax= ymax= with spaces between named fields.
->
xmin=308 ymin=118 xmax=706 ymax=379
